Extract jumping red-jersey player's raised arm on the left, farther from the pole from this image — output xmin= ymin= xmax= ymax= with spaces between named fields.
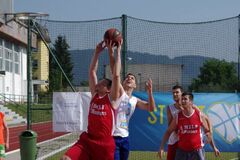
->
xmin=89 ymin=41 xmax=105 ymax=95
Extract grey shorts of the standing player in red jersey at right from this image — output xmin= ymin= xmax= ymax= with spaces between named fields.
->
xmin=175 ymin=148 xmax=205 ymax=160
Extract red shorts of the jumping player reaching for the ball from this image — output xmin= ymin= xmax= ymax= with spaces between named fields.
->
xmin=65 ymin=132 xmax=115 ymax=160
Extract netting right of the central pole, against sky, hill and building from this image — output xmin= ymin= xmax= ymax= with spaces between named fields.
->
xmin=127 ymin=17 xmax=239 ymax=91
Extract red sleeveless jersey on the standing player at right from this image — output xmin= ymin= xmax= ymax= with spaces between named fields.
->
xmin=177 ymin=109 xmax=203 ymax=151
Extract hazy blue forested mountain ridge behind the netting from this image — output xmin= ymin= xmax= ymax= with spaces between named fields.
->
xmin=70 ymin=49 xmax=211 ymax=86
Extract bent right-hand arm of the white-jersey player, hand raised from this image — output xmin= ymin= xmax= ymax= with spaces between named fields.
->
xmin=137 ymin=78 xmax=156 ymax=111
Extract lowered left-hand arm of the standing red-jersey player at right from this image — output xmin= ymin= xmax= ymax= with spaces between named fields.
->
xmin=158 ymin=117 xmax=177 ymax=159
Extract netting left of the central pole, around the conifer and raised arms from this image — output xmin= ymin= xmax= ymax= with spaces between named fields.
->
xmin=41 ymin=18 xmax=121 ymax=86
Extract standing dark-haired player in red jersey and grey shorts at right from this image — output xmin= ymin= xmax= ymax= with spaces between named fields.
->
xmin=159 ymin=92 xmax=212 ymax=160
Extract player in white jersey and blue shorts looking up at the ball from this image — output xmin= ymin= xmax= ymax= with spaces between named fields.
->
xmin=107 ymin=41 xmax=156 ymax=160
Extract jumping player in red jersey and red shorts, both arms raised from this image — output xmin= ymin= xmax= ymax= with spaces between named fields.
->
xmin=62 ymin=41 xmax=122 ymax=160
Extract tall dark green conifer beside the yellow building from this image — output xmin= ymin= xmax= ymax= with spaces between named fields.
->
xmin=49 ymin=36 xmax=73 ymax=91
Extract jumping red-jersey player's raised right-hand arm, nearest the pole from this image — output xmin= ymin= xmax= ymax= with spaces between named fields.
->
xmin=110 ymin=41 xmax=122 ymax=109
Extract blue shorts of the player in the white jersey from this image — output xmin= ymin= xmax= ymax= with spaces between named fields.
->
xmin=114 ymin=136 xmax=129 ymax=160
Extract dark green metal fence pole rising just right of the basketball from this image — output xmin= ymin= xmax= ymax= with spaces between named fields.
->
xmin=122 ymin=14 xmax=127 ymax=79
